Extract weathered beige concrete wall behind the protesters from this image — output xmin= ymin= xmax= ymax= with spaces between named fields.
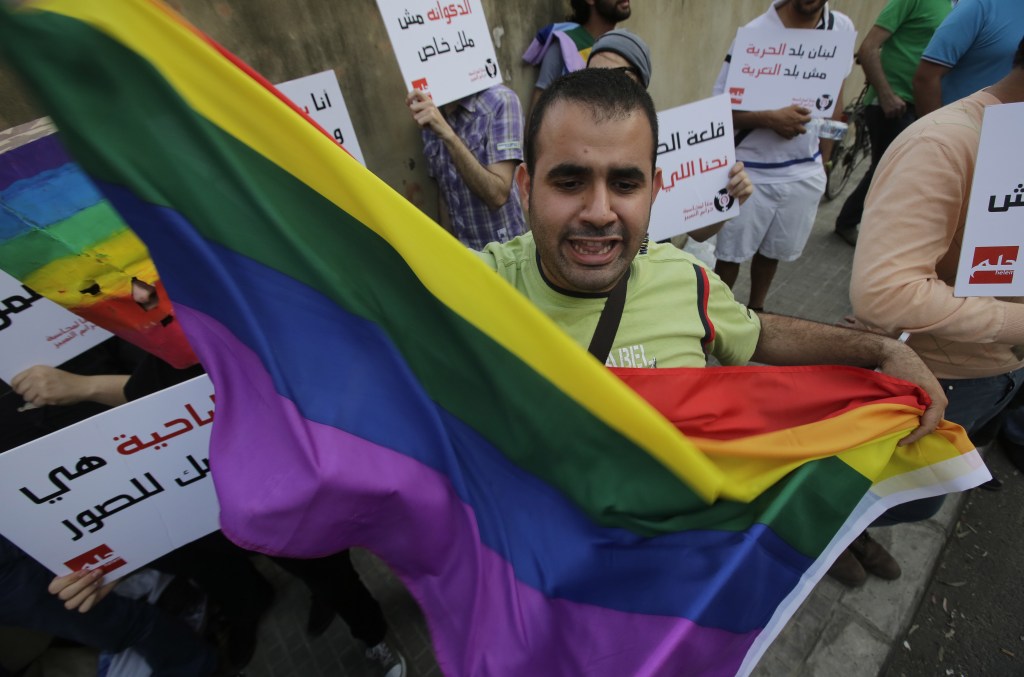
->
xmin=0 ymin=0 xmax=885 ymax=216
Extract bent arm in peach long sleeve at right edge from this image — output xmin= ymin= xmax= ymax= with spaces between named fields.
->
xmin=850 ymin=133 xmax=1024 ymax=344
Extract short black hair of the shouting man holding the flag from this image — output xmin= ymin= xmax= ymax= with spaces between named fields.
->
xmin=526 ymin=69 xmax=657 ymax=176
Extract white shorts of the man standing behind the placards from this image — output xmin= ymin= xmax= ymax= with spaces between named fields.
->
xmin=715 ymin=172 xmax=825 ymax=263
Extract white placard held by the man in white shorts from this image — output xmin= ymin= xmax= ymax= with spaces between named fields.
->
xmin=725 ymin=28 xmax=857 ymax=118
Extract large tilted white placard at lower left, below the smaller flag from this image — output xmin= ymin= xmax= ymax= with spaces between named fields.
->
xmin=0 ymin=376 xmax=220 ymax=581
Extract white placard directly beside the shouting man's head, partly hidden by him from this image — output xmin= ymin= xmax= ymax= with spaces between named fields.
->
xmin=649 ymin=94 xmax=739 ymax=242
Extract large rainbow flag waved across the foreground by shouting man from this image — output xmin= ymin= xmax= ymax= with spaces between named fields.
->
xmin=0 ymin=0 xmax=988 ymax=677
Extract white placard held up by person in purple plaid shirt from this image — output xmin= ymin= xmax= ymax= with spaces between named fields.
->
xmin=377 ymin=0 xmax=502 ymax=105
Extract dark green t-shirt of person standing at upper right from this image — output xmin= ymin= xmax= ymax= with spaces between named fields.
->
xmin=864 ymin=0 xmax=952 ymax=103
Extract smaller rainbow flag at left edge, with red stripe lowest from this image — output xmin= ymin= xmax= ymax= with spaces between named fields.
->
xmin=0 ymin=120 xmax=197 ymax=367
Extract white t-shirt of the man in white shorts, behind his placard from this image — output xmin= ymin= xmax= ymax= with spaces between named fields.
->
xmin=714 ymin=2 xmax=856 ymax=184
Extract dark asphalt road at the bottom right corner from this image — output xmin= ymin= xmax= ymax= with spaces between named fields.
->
xmin=883 ymin=449 xmax=1024 ymax=677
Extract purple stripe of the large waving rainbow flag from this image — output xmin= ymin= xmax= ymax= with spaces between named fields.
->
xmin=176 ymin=305 xmax=759 ymax=676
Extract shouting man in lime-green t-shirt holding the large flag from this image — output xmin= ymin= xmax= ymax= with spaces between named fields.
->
xmin=477 ymin=69 xmax=945 ymax=432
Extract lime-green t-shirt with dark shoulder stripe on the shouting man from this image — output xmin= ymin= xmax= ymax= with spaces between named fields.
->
xmin=476 ymin=232 xmax=761 ymax=367
